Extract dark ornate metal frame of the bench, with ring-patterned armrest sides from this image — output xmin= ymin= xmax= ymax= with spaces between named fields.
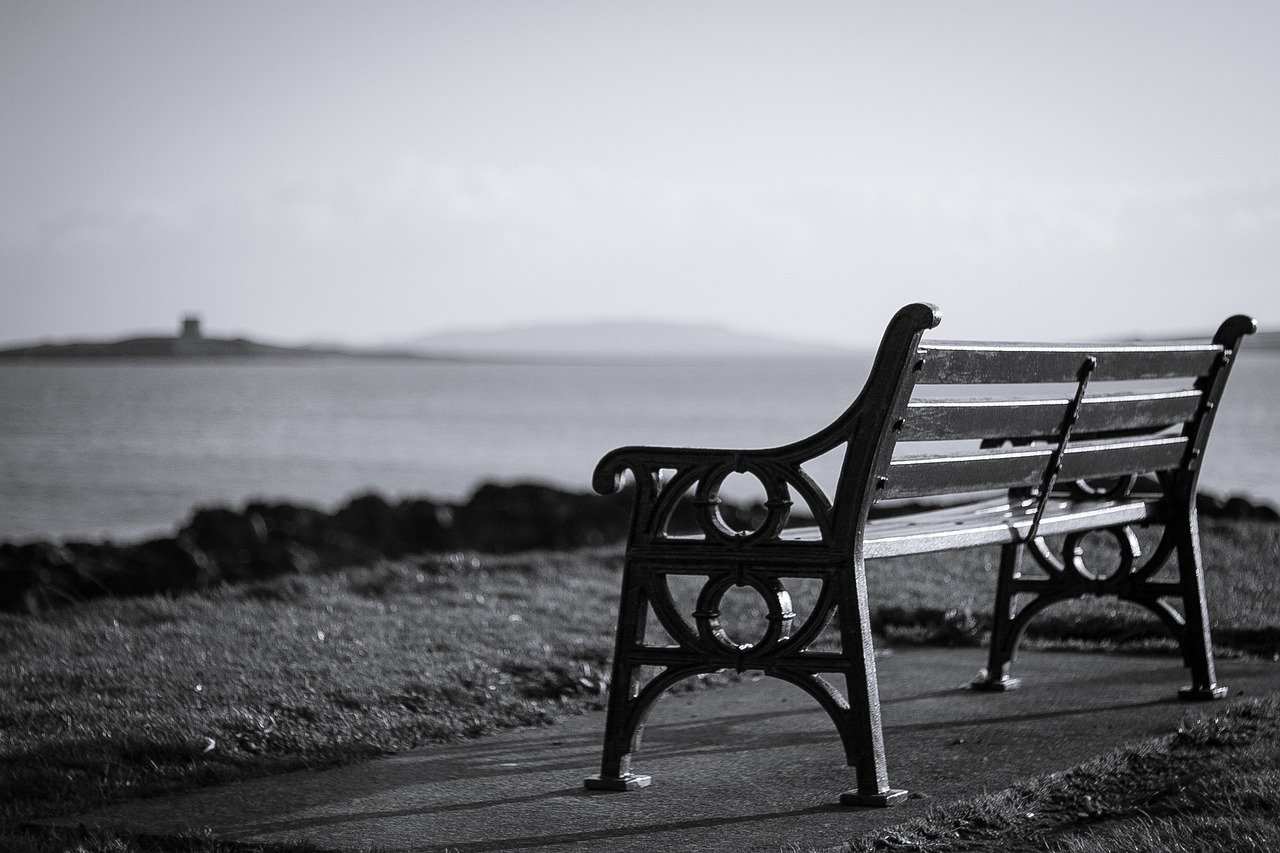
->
xmin=585 ymin=304 xmax=1254 ymax=806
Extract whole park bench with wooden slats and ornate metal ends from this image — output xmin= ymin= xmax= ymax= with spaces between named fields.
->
xmin=585 ymin=304 xmax=1256 ymax=806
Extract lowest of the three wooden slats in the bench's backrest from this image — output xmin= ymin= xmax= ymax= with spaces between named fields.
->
xmin=879 ymin=435 xmax=1187 ymax=500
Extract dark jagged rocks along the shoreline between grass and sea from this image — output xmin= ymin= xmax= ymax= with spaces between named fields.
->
xmin=0 ymin=483 xmax=1280 ymax=612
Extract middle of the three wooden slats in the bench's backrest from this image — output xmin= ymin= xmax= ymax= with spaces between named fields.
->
xmin=899 ymin=391 xmax=1203 ymax=442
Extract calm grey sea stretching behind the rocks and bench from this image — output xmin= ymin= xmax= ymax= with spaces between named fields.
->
xmin=0 ymin=351 xmax=1280 ymax=542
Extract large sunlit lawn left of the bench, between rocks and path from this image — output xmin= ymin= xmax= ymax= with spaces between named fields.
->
xmin=0 ymin=555 xmax=618 ymax=850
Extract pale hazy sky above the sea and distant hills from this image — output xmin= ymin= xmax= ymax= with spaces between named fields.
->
xmin=0 ymin=0 xmax=1280 ymax=345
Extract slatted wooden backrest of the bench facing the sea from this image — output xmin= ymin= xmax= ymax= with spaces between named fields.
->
xmin=846 ymin=305 xmax=1254 ymax=522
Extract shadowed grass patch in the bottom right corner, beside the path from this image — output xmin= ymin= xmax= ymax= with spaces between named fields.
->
xmin=846 ymin=698 xmax=1280 ymax=853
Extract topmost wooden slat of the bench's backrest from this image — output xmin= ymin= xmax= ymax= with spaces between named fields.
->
xmin=916 ymin=342 xmax=1221 ymax=386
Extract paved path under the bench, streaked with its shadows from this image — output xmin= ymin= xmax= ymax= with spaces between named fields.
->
xmin=49 ymin=648 xmax=1280 ymax=853
